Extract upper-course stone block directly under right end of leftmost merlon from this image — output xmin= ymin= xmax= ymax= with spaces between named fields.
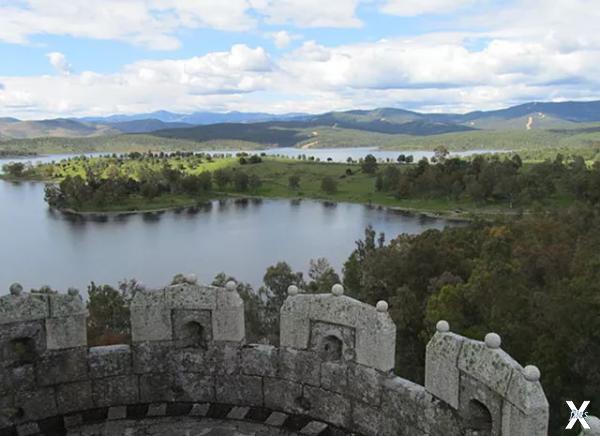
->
xmin=36 ymin=348 xmax=88 ymax=386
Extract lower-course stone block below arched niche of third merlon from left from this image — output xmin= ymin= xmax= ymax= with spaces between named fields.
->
xmin=303 ymin=386 xmax=352 ymax=428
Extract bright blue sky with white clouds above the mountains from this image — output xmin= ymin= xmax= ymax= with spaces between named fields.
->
xmin=0 ymin=0 xmax=600 ymax=119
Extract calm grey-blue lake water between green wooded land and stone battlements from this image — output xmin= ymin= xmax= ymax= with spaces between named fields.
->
xmin=0 ymin=150 xmax=468 ymax=294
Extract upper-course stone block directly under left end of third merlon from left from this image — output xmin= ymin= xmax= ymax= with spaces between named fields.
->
xmin=277 ymin=348 xmax=321 ymax=386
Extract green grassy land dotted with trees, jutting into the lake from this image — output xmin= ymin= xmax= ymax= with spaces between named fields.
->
xmin=2 ymin=149 xmax=600 ymax=218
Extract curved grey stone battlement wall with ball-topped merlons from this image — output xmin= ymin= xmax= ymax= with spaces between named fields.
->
xmin=0 ymin=280 xmax=548 ymax=436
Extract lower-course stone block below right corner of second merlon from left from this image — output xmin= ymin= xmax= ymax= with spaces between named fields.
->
xmin=215 ymin=375 xmax=263 ymax=406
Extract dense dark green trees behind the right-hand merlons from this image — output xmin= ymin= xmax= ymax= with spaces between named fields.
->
xmin=344 ymin=206 xmax=600 ymax=429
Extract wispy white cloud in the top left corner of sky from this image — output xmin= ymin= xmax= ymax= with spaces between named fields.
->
xmin=0 ymin=0 xmax=255 ymax=50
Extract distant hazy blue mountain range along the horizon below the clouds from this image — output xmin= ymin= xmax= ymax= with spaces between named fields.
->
xmin=0 ymin=101 xmax=600 ymax=146
